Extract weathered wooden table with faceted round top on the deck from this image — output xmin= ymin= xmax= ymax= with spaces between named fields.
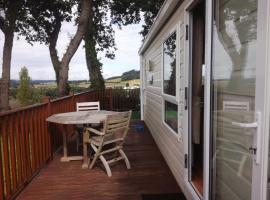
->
xmin=46 ymin=110 xmax=117 ymax=168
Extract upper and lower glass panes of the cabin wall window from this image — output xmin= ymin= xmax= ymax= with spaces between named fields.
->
xmin=163 ymin=31 xmax=178 ymax=134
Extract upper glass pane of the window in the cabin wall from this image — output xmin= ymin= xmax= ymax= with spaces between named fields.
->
xmin=163 ymin=32 xmax=176 ymax=96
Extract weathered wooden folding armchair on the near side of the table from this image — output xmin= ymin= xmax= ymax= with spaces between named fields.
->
xmin=83 ymin=111 xmax=132 ymax=177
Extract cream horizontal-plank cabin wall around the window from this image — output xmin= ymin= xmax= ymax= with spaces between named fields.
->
xmin=141 ymin=0 xmax=195 ymax=199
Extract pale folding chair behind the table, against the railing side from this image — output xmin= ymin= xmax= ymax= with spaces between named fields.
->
xmin=76 ymin=101 xmax=100 ymax=152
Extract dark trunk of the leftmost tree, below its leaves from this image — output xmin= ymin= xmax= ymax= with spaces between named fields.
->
xmin=0 ymin=31 xmax=14 ymax=111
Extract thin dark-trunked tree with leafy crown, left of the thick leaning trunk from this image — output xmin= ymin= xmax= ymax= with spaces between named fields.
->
xmin=19 ymin=0 xmax=75 ymax=88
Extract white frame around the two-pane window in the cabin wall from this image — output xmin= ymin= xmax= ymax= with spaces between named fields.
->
xmin=161 ymin=23 xmax=182 ymax=138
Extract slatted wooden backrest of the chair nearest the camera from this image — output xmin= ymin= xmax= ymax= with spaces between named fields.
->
xmin=103 ymin=111 xmax=132 ymax=142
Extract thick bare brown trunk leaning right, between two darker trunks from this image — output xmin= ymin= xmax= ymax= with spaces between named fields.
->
xmin=58 ymin=0 xmax=92 ymax=96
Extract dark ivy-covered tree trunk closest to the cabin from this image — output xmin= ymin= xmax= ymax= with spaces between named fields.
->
xmin=84 ymin=22 xmax=105 ymax=90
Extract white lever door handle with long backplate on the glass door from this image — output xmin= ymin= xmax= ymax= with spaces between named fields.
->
xmin=232 ymin=112 xmax=262 ymax=164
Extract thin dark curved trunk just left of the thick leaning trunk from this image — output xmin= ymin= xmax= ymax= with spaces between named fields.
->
xmin=49 ymin=18 xmax=62 ymax=86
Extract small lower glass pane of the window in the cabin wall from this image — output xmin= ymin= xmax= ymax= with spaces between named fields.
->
xmin=164 ymin=101 xmax=178 ymax=133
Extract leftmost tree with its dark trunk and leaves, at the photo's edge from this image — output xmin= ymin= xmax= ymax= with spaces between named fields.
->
xmin=0 ymin=0 xmax=25 ymax=110
